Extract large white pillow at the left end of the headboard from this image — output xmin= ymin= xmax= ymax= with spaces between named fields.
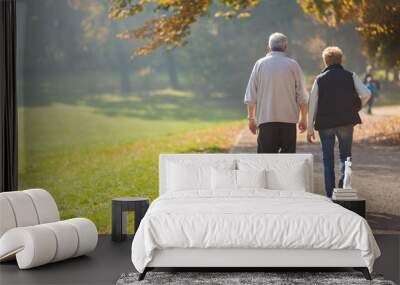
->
xmin=167 ymin=162 xmax=211 ymax=191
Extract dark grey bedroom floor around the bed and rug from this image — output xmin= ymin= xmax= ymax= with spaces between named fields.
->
xmin=0 ymin=235 xmax=400 ymax=285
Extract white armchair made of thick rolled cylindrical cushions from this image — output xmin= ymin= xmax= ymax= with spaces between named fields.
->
xmin=0 ymin=189 xmax=98 ymax=269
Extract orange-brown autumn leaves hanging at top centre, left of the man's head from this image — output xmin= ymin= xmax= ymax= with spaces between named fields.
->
xmin=109 ymin=0 xmax=259 ymax=55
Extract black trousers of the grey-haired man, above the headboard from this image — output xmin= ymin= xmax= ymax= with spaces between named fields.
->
xmin=257 ymin=122 xmax=297 ymax=153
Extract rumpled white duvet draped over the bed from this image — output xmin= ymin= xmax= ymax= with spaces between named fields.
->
xmin=132 ymin=189 xmax=380 ymax=272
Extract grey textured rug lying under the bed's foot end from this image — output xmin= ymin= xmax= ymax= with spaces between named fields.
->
xmin=117 ymin=272 xmax=395 ymax=285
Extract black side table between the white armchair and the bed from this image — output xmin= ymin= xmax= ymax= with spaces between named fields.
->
xmin=111 ymin=197 xmax=150 ymax=241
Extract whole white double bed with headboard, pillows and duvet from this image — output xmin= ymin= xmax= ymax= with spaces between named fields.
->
xmin=132 ymin=154 xmax=380 ymax=279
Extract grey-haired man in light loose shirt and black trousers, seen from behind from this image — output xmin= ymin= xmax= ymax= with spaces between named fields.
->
xmin=244 ymin=33 xmax=308 ymax=153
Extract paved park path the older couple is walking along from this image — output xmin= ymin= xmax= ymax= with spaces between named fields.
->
xmin=231 ymin=106 xmax=400 ymax=233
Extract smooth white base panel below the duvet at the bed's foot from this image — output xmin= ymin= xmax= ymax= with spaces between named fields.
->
xmin=147 ymin=248 xmax=367 ymax=267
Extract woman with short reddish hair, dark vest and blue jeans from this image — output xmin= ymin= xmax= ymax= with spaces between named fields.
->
xmin=307 ymin=47 xmax=371 ymax=198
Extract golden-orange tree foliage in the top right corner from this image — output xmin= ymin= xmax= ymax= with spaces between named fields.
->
xmin=298 ymin=0 xmax=400 ymax=67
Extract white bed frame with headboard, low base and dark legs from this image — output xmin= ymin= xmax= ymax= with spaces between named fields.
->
xmin=139 ymin=154 xmax=371 ymax=280
